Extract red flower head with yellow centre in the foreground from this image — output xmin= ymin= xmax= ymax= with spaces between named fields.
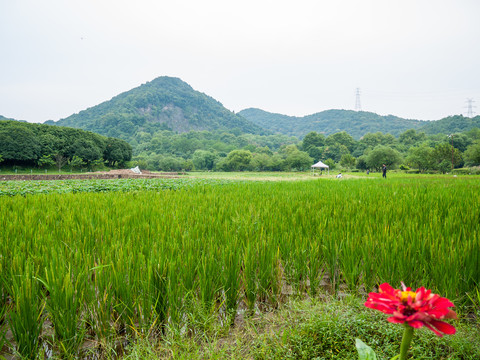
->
xmin=365 ymin=282 xmax=457 ymax=337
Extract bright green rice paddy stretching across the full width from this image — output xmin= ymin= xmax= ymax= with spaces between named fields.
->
xmin=0 ymin=176 xmax=480 ymax=358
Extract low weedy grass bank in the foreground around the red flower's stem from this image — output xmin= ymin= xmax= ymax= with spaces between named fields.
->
xmin=117 ymin=297 xmax=480 ymax=360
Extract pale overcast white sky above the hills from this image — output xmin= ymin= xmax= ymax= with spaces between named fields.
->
xmin=0 ymin=0 xmax=480 ymax=122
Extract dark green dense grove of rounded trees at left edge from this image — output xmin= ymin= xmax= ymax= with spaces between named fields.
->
xmin=0 ymin=120 xmax=132 ymax=170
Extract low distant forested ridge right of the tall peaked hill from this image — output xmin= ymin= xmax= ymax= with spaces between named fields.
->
xmin=239 ymin=108 xmax=423 ymax=139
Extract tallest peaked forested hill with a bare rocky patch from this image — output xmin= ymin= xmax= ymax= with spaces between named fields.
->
xmin=46 ymin=76 xmax=266 ymax=141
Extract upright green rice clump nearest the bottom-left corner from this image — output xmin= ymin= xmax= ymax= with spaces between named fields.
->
xmin=8 ymin=264 xmax=45 ymax=359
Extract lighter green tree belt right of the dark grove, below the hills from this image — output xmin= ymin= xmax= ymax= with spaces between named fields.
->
xmin=132 ymin=128 xmax=480 ymax=173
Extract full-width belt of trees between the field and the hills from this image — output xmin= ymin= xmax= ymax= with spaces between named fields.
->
xmin=0 ymin=121 xmax=480 ymax=172
